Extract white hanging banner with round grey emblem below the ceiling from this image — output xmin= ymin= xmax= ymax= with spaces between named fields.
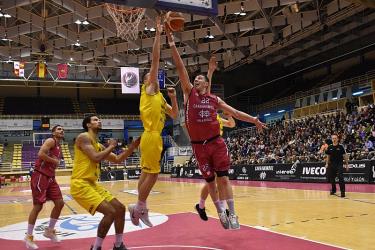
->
xmin=121 ymin=67 xmax=140 ymax=94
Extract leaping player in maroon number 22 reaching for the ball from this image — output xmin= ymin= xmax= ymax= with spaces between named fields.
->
xmin=166 ymin=29 xmax=265 ymax=229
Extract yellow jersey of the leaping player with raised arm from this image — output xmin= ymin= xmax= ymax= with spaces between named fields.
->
xmin=139 ymin=84 xmax=167 ymax=134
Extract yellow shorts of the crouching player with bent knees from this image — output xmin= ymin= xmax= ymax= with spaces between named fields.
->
xmin=70 ymin=179 xmax=114 ymax=215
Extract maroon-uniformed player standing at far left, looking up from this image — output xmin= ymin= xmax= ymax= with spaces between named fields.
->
xmin=24 ymin=125 xmax=64 ymax=249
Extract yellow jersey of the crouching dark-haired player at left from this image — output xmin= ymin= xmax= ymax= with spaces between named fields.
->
xmin=71 ymin=132 xmax=101 ymax=182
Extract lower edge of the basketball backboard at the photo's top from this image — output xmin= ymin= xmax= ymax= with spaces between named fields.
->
xmin=96 ymin=0 xmax=218 ymax=16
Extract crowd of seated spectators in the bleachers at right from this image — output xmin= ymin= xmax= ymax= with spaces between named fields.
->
xmin=226 ymin=105 xmax=375 ymax=165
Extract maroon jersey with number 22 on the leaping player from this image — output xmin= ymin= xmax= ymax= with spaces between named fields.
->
xmin=185 ymin=88 xmax=220 ymax=141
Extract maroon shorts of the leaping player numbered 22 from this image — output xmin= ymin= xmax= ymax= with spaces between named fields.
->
xmin=192 ymin=137 xmax=230 ymax=179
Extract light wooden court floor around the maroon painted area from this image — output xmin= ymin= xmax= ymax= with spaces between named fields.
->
xmin=0 ymin=176 xmax=375 ymax=249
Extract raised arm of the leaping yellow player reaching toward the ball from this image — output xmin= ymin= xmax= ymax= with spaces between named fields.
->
xmin=145 ymin=17 xmax=163 ymax=95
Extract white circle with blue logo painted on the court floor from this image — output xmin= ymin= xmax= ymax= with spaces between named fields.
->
xmin=0 ymin=213 xmax=168 ymax=241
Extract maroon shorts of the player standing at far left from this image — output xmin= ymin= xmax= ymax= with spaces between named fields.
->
xmin=30 ymin=171 xmax=62 ymax=204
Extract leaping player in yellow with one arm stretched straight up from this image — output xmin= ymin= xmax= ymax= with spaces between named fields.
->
xmin=129 ymin=17 xmax=178 ymax=227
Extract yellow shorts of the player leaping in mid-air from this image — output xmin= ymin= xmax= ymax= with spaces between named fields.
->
xmin=140 ymin=131 xmax=163 ymax=174
